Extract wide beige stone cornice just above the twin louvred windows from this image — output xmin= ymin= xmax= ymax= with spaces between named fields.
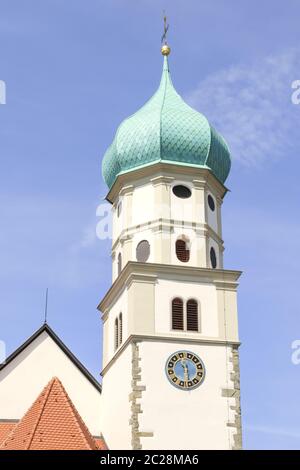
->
xmin=97 ymin=261 xmax=241 ymax=312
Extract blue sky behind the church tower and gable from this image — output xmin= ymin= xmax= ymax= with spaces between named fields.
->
xmin=0 ymin=0 xmax=300 ymax=449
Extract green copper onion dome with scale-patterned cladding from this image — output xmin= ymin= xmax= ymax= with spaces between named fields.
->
xmin=102 ymin=57 xmax=231 ymax=188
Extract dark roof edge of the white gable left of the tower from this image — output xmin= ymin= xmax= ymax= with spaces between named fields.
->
xmin=0 ymin=323 xmax=101 ymax=392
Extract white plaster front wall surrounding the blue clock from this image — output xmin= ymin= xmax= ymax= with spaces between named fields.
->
xmin=139 ymin=341 xmax=234 ymax=449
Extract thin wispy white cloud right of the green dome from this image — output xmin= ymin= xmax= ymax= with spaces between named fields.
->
xmin=186 ymin=49 xmax=300 ymax=166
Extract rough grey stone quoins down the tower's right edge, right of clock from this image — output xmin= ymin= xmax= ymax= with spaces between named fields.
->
xmin=222 ymin=345 xmax=242 ymax=450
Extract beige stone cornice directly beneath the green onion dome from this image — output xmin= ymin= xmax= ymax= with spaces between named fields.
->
xmin=106 ymin=162 xmax=228 ymax=204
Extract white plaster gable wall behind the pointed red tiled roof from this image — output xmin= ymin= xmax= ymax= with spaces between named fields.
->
xmin=0 ymin=332 xmax=101 ymax=436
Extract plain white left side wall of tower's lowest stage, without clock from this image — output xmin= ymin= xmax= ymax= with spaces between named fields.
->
xmin=100 ymin=345 xmax=132 ymax=450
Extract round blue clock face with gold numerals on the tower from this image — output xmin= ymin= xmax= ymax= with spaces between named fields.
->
xmin=166 ymin=351 xmax=205 ymax=390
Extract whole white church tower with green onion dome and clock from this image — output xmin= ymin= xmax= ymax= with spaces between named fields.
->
xmin=99 ymin=38 xmax=241 ymax=449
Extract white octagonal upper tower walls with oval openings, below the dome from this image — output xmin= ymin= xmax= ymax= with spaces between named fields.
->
xmin=113 ymin=180 xmax=222 ymax=272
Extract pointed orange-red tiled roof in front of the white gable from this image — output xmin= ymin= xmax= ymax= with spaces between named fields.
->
xmin=0 ymin=377 xmax=101 ymax=450
